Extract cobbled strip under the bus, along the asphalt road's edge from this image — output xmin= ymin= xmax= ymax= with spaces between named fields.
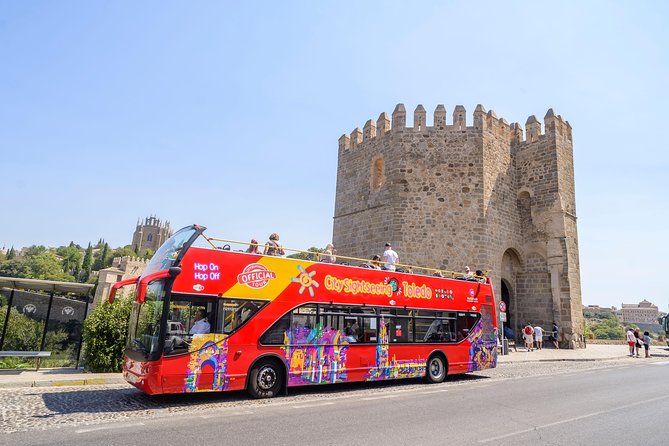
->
xmin=0 ymin=358 xmax=666 ymax=433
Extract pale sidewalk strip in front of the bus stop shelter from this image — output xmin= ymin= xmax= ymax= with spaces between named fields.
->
xmin=0 ymin=368 xmax=125 ymax=388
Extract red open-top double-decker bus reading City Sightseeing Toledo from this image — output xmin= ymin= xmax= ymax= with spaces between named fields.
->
xmin=110 ymin=225 xmax=497 ymax=398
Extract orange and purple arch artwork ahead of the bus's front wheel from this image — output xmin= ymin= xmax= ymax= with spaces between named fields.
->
xmin=183 ymin=334 xmax=229 ymax=393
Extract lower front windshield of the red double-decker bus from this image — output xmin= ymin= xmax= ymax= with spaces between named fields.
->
xmin=126 ymin=280 xmax=165 ymax=360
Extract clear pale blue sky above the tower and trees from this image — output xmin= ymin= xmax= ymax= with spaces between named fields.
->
xmin=0 ymin=0 xmax=669 ymax=311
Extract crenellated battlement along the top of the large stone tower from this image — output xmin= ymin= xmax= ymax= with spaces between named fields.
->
xmin=339 ymin=104 xmax=571 ymax=150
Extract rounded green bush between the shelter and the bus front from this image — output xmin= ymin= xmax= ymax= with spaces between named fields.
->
xmin=83 ymin=298 xmax=133 ymax=372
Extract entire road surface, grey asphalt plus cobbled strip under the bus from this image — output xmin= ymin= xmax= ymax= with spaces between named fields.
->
xmin=0 ymin=358 xmax=669 ymax=446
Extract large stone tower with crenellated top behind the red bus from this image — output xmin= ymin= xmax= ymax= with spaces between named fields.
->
xmin=333 ymin=104 xmax=583 ymax=348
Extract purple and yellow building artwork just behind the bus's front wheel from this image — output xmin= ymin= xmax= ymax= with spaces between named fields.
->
xmin=282 ymin=324 xmax=348 ymax=386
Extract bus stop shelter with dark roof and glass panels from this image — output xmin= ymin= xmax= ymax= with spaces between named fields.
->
xmin=0 ymin=277 xmax=94 ymax=368
